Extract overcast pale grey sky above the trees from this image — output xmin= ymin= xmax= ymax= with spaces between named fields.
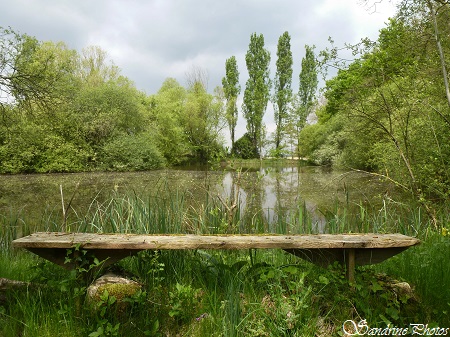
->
xmin=0 ymin=0 xmax=395 ymax=143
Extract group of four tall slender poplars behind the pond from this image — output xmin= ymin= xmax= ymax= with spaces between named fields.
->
xmin=222 ymin=32 xmax=319 ymax=159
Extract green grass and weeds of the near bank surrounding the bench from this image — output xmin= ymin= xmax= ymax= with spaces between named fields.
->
xmin=0 ymin=190 xmax=450 ymax=336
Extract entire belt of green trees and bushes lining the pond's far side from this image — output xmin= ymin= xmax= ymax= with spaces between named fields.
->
xmin=0 ymin=0 xmax=450 ymax=202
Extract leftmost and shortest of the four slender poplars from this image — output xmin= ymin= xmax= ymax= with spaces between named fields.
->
xmin=222 ymin=56 xmax=241 ymax=153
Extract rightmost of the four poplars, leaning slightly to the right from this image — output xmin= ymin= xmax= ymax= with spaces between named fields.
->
xmin=291 ymin=45 xmax=318 ymax=155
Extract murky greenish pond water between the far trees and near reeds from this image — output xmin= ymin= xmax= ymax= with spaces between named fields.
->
xmin=0 ymin=165 xmax=404 ymax=230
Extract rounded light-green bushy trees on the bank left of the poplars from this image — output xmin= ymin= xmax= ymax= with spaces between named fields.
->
xmin=0 ymin=29 xmax=230 ymax=173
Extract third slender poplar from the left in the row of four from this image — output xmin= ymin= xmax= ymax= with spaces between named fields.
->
xmin=273 ymin=32 xmax=293 ymax=156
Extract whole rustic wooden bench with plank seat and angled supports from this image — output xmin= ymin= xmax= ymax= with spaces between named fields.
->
xmin=13 ymin=232 xmax=420 ymax=282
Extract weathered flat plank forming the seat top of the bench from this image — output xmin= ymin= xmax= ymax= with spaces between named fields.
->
xmin=13 ymin=232 xmax=419 ymax=250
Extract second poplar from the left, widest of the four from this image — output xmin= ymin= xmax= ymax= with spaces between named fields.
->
xmin=242 ymin=33 xmax=271 ymax=156
